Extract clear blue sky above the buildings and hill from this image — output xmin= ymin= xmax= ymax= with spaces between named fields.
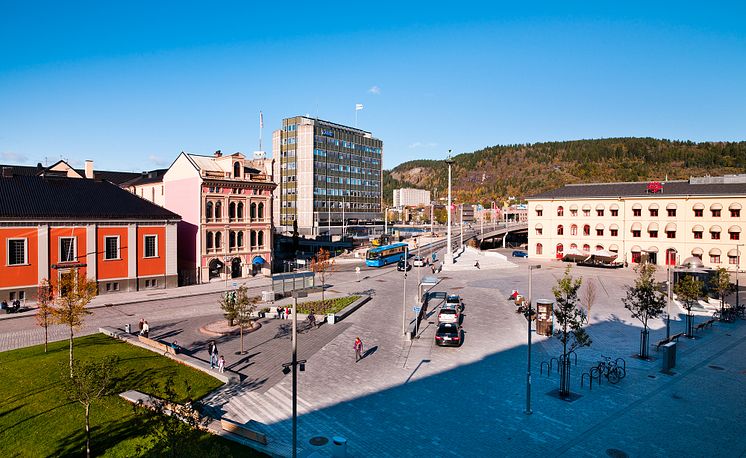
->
xmin=0 ymin=0 xmax=746 ymax=171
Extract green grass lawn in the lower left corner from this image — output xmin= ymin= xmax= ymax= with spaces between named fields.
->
xmin=0 ymin=334 xmax=263 ymax=457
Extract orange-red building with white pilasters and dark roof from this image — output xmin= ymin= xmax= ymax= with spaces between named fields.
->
xmin=0 ymin=167 xmax=180 ymax=301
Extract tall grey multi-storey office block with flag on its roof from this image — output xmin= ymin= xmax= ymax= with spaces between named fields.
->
xmin=272 ymin=116 xmax=383 ymax=235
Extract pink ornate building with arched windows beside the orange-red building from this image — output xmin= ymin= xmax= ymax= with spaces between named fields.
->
xmin=163 ymin=151 xmax=276 ymax=284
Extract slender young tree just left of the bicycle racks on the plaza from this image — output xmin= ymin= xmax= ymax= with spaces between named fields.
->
xmin=552 ymin=267 xmax=592 ymax=397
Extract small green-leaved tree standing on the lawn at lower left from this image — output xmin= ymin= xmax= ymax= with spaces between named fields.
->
xmin=60 ymin=356 xmax=119 ymax=458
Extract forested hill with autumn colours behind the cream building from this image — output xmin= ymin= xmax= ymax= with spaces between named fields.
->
xmin=384 ymin=138 xmax=746 ymax=204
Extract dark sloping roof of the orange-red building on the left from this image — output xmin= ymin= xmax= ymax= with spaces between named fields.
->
xmin=0 ymin=175 xmax=181 ymax=221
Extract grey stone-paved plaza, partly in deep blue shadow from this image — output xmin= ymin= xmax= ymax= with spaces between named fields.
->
xmin=0 ymin=253 xmax=746 ymax=457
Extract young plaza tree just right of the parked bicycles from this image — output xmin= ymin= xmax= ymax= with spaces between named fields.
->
xmin=622 ymin=263 xmax=666 ymax=359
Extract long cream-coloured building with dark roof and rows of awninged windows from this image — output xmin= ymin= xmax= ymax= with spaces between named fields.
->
xmin=528 ymin=175 xmax=746 ymax=270
